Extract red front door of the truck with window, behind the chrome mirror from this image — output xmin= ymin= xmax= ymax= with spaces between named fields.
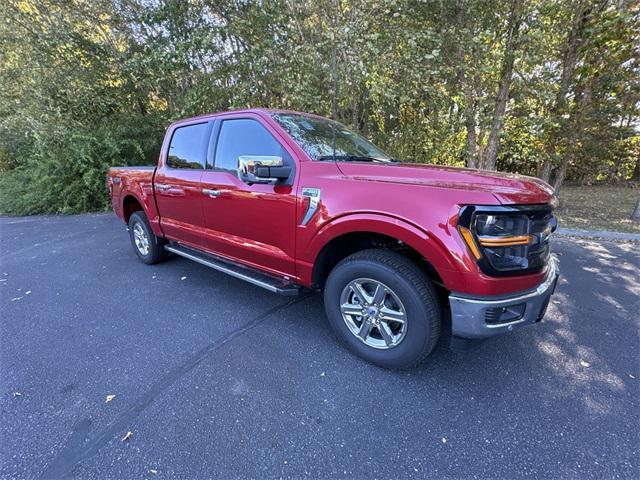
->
xmin=202 ymin=116 xmax=296 ymax=276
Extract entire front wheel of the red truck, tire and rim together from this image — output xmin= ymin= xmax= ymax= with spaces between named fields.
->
xmin=324 ymin=250 xmax=441 ymax=368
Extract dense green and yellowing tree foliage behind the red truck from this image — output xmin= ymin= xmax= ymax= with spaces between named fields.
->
xmin=0 ymin=0 xmax=640 ymax=214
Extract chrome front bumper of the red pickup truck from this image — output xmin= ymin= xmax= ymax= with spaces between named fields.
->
xmin=449 ymin=257 xmax=559 ymax=339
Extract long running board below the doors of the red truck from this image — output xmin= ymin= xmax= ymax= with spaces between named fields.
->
xmin=164 ymin=244 xmax=302 ymax=296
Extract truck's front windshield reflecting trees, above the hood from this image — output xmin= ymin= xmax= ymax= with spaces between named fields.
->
xmin=273 ymin=113 xmax=393 ymax=162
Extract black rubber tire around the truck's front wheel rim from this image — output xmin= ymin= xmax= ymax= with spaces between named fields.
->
xmin=324 ymin=249 xmax=442 ymax=369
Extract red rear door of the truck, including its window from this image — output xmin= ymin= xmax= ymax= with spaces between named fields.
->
xmin=154 ymin=121 xmax=212 ymax=248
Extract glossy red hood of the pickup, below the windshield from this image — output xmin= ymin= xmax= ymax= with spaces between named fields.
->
xmin=338 ymin=162 xmax=553 ymax=205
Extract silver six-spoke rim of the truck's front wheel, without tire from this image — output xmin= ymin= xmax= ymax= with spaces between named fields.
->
xmin=340 ymin=278 xmax=407 ymax=350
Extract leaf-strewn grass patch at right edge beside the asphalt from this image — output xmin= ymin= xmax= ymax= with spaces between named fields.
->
xmin=556 ymin=185 xmax=640 ymax=233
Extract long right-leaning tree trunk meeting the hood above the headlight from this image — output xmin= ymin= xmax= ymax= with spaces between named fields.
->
xmin=484 ymin=0 xmax=522 ymax=170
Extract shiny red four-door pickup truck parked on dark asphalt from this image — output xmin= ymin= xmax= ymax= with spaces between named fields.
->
xmin=108 ymin=109 xmax=558 ymax=368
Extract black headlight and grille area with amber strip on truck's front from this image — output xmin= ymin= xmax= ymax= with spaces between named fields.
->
xmin=458 ymin=205 xmax=556 ymax=276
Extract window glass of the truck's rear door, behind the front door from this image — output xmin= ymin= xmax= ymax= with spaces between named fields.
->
xmin=167 ymin=122 xmax=209 ymax=169
